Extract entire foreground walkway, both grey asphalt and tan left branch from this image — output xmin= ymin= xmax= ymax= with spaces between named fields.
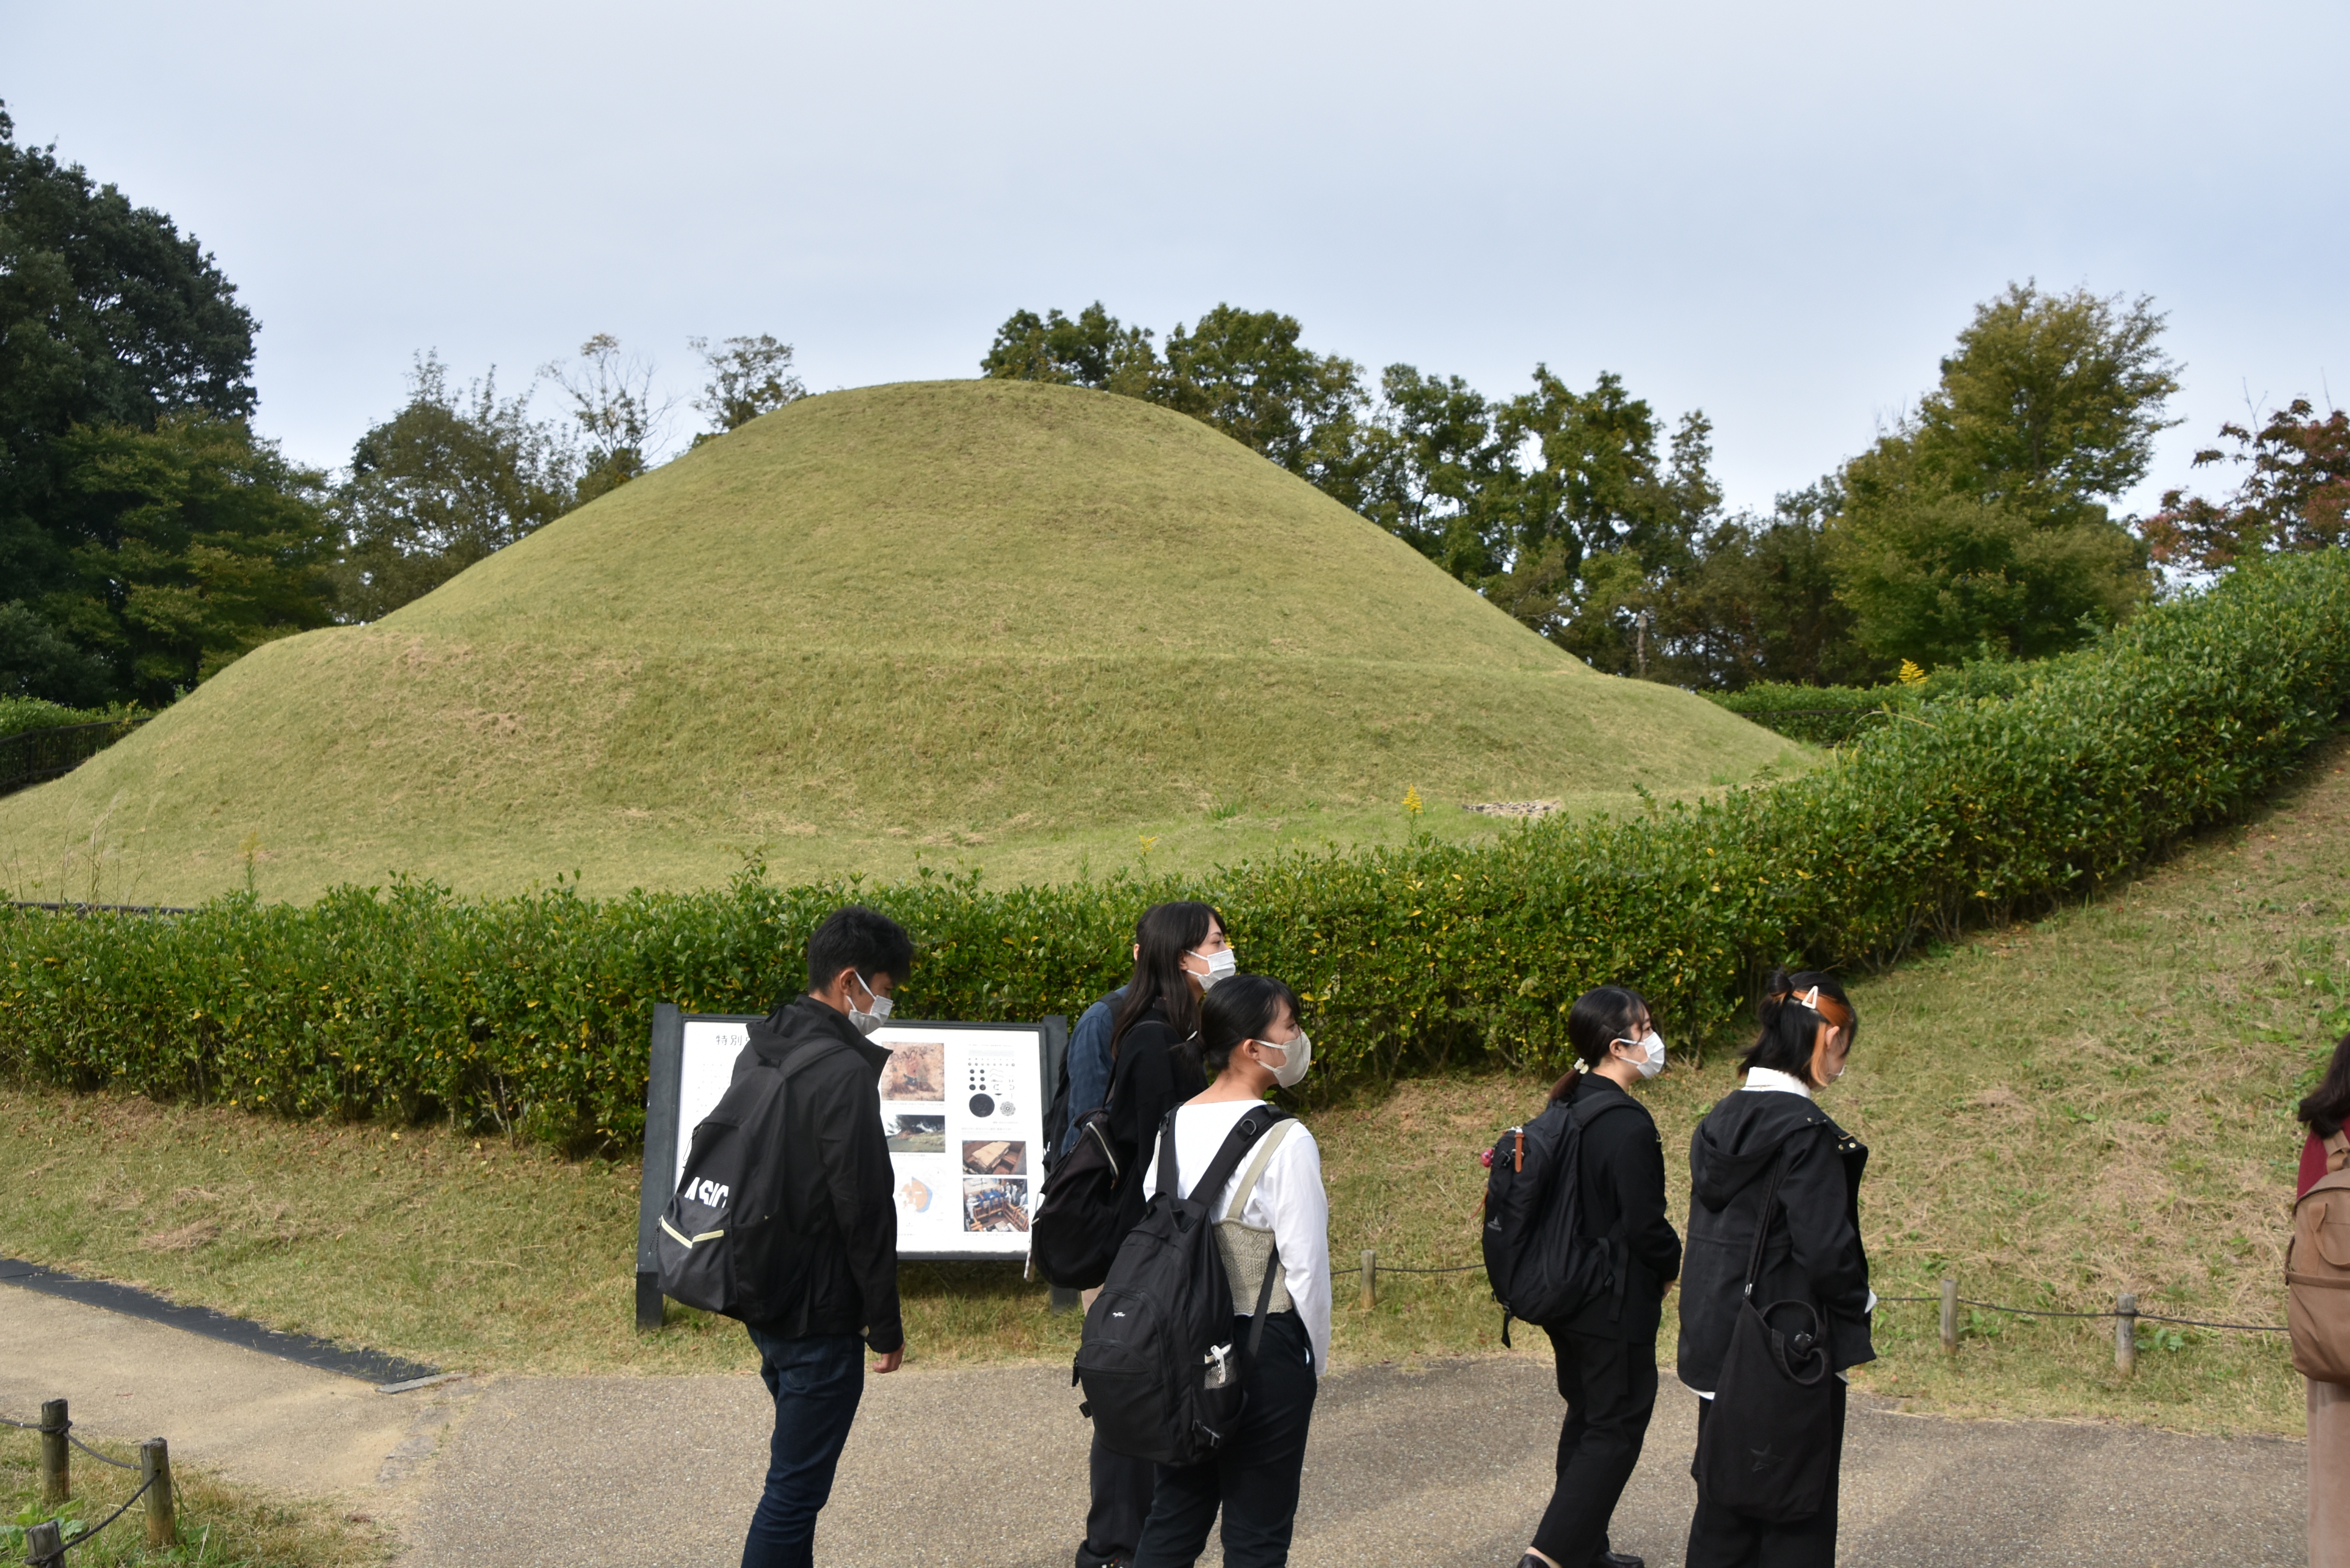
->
xmin=0 ymin=1286 xmax=2306 ymax=1568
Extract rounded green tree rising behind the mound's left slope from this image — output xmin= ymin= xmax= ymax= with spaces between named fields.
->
xmin=331 ymin=355 xmax=578 ymax=620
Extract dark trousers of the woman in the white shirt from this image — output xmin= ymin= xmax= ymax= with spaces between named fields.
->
xmin=1135 ymin=1312 xmax=1316 ymax=1568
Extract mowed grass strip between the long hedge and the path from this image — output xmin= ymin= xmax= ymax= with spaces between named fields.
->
xmin=0 ymin=743 xmax=2350 ymax=1432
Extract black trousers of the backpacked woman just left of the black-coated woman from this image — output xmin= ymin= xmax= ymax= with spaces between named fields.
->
xmin=1535 ymin=1328 xmax=1657 ymax=1568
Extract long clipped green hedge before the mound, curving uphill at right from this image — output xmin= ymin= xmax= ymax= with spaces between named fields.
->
xmin=14 ymin=552 xmax=2350 ymax=1145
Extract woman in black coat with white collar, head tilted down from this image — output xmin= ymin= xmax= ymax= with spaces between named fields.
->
xmin=1680 ymin=971 xmax=1877 ymax=1568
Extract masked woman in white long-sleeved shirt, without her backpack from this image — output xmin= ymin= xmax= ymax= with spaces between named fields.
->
xmin=1133 ymin=976 xmax=1330 ymax=1568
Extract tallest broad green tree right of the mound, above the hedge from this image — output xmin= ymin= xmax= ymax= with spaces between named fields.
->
xmin=1830 ymin=284 xmax=2179 ymax=665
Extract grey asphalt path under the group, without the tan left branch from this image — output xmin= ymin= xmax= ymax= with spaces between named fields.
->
xmin=402 ymin=1354 xmax=2308 ymax=1568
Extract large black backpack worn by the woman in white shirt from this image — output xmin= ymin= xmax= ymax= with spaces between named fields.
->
xmin=1069 ymin=1105 xmax=1288 ymax=1465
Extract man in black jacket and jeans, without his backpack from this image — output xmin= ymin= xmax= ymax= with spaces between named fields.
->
xmin=735 ymin=905 xmax=914 ymax=1568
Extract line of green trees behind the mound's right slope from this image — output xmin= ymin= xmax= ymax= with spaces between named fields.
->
xmin=980 ymin=294 xmax=2350 ymax=689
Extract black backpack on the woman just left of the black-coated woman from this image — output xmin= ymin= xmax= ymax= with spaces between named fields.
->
xmin=1485 ymin=1098 xmax=1629 ymax=1345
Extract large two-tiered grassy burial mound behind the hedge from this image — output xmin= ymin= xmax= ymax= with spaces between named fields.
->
xmin=0 ymin=381 xmax=1795 ymax=903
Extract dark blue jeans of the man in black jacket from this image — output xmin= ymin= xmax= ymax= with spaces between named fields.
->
xmin=743 ymin=1328 xmax=865 ymax=1568
